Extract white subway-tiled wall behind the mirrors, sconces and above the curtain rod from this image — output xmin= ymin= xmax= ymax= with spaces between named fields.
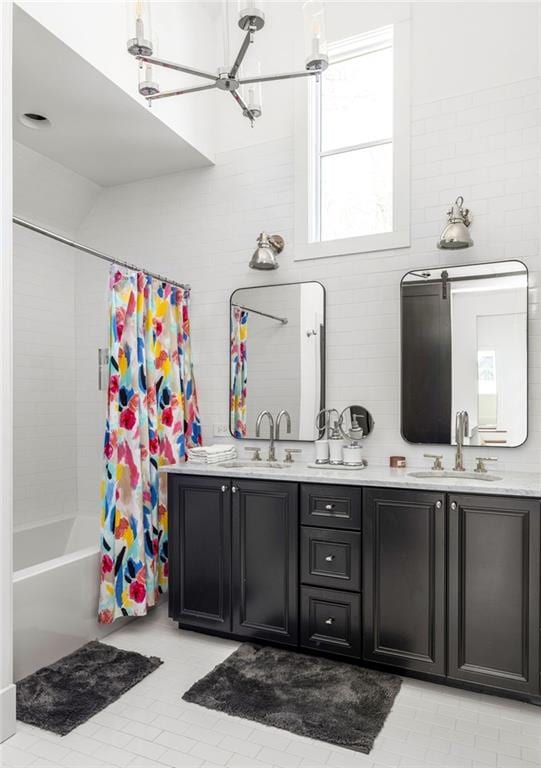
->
xmin=78 ymin=78 xmax=541 ymax=471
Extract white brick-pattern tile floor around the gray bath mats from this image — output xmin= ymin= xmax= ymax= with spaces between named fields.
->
xmin=0 ymin=606 xmax=541 ymax=768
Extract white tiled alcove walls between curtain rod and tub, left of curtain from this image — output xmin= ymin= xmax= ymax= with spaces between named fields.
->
xmin=13 ymin=227 xmax=108 ymax=541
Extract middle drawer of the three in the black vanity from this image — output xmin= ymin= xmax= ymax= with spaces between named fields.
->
xmin=301 ymin=526 xmax=361 ymax=592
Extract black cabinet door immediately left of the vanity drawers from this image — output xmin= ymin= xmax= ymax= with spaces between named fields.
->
xmin=232 ymin=480 xmax=298 ymax=645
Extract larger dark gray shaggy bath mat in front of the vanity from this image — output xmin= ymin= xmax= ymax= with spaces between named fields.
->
xmin=182 ymin=643 xmax=401 ymax=754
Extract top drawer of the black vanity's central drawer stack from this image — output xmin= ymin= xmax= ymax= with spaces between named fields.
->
xmin=301 ymin=483 xmax=362 ymax=531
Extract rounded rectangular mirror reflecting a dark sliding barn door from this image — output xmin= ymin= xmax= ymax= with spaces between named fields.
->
xmin=401 ymin=261 xmax=528 ymax=447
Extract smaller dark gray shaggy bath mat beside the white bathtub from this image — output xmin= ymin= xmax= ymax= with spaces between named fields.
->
xmin=17 ymin=640 xmax=163 ymax=736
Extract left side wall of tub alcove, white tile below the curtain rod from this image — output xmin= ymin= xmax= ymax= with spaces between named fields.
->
xmin=13 ymin=227 xmax=77 ymax=527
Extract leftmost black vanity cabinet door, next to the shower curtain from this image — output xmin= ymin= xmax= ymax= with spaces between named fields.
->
xmin=167 ymin=473 xmax=231 ymax=632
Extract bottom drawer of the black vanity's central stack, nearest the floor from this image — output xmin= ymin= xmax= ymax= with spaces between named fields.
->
xmin=301 ymin=587 xmax=361 ymax=658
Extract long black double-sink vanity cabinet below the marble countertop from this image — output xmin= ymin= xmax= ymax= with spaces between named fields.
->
xmin=168 ymin=473 xmax=541 ymax=703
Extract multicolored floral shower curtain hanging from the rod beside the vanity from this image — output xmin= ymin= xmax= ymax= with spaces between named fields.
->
xmin=99 ymin=266 xmax=201 ymax=624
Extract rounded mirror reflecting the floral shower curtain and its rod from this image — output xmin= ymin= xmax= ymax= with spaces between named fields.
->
xmin=229 ymin=282 xmax=325 ymax=440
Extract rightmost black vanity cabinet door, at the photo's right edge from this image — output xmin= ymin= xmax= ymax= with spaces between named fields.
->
xmin=448 ymin=494 xmax=540 ymax=693
